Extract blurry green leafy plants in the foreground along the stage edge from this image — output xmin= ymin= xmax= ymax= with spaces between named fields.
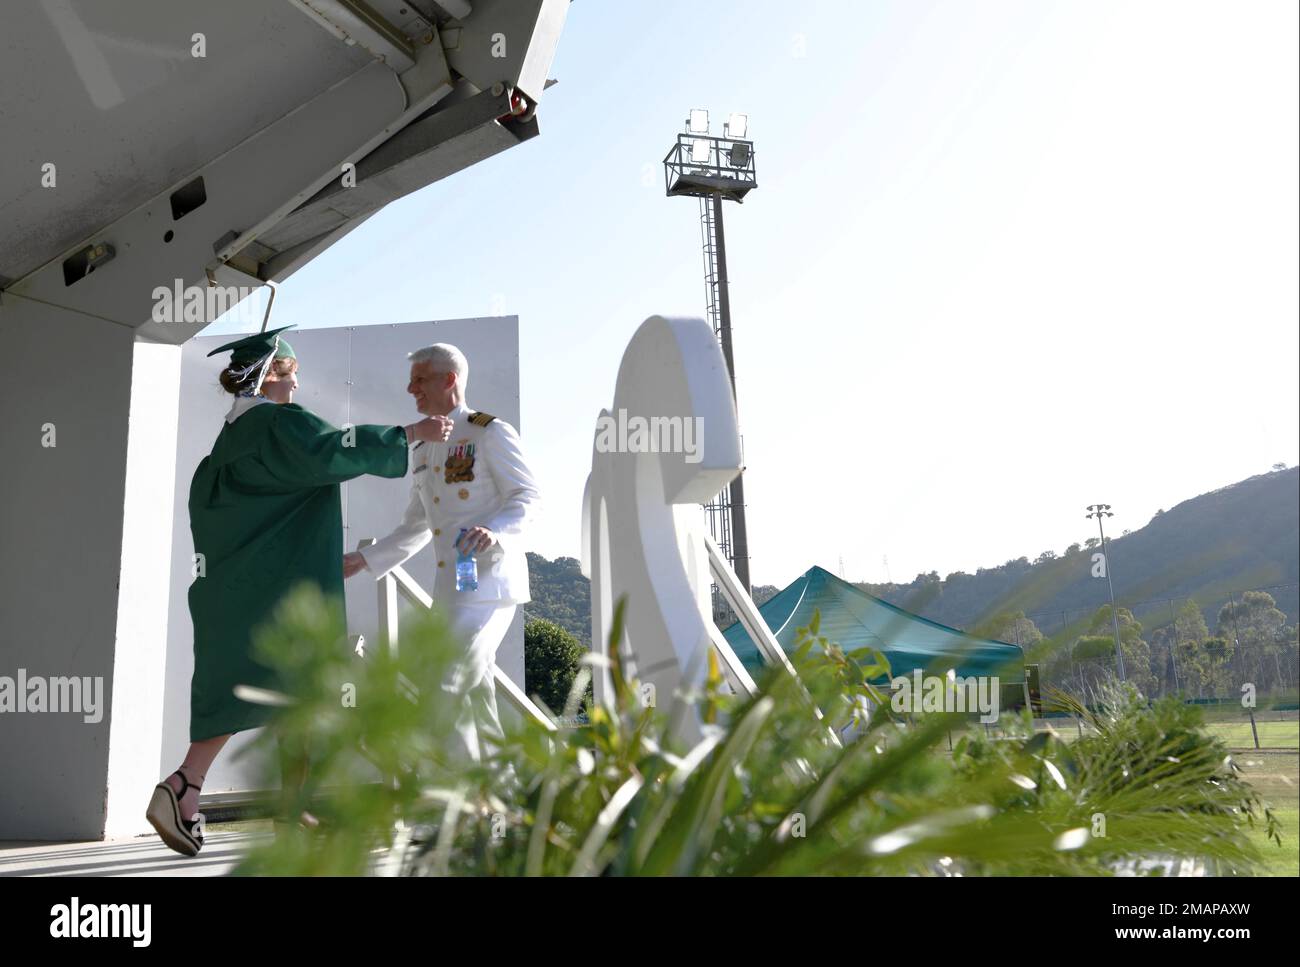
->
xmin=238 ymin=584 xmax=1281 ymax=876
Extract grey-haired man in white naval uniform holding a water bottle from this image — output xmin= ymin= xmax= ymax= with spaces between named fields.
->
xmin=343 ymin=343 xmax=540 ymax=760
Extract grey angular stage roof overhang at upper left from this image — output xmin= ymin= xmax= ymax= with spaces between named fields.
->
xmin=0 ymin=0 xmax=568 ymax=343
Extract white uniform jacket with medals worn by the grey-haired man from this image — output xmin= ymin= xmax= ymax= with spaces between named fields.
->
xmin=360 ymin=404 xmax=541 ymax=604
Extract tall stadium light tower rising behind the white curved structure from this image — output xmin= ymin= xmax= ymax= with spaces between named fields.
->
xmin=663 ymin=108 xmax=758 ymax=600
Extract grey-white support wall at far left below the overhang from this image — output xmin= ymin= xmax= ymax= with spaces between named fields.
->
xmin=0 ymin=294 xmax=179 ymax=840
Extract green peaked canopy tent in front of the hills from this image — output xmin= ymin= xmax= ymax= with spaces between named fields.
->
xmin=723 ymin=567 xmax=1024 ymax=691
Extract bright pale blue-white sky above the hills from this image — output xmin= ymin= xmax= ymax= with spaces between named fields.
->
xmin=209 ymin=0 xmax=1300 ymax=586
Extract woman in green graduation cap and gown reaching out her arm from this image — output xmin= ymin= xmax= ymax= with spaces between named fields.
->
xmin=147 ymin=326 xmax=451 ymax=855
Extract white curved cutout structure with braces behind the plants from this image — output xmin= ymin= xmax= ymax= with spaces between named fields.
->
xmin=582 ymin=316 xmax=789 ymax=740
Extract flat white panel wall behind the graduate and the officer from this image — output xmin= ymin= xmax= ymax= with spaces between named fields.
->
xmin=162 ymin=317 xmax=522 ymax=794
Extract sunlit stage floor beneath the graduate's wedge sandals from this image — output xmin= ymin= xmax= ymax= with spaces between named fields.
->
xmin=0 ymin=829 xmax=272 ymax=876
